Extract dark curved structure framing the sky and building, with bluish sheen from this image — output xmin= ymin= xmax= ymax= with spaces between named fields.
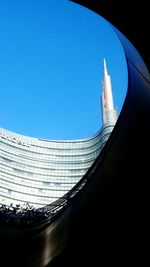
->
xmin=0 ymin=0 xmax=150 ymax=267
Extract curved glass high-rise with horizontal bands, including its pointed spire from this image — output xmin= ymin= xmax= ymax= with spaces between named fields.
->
xmin=0 ymin=59 xmax=117 ymax=208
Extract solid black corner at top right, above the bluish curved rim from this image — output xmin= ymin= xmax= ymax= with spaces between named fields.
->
xmin=72 ymin=0 xmax=150 ymax=69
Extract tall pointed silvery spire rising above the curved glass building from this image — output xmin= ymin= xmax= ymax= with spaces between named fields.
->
xmin=101 ymin=58 xmax=116 ymax=125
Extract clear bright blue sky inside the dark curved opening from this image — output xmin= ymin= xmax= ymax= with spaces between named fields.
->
xmin=0 ymin=0 xmax=127 ymax=139
